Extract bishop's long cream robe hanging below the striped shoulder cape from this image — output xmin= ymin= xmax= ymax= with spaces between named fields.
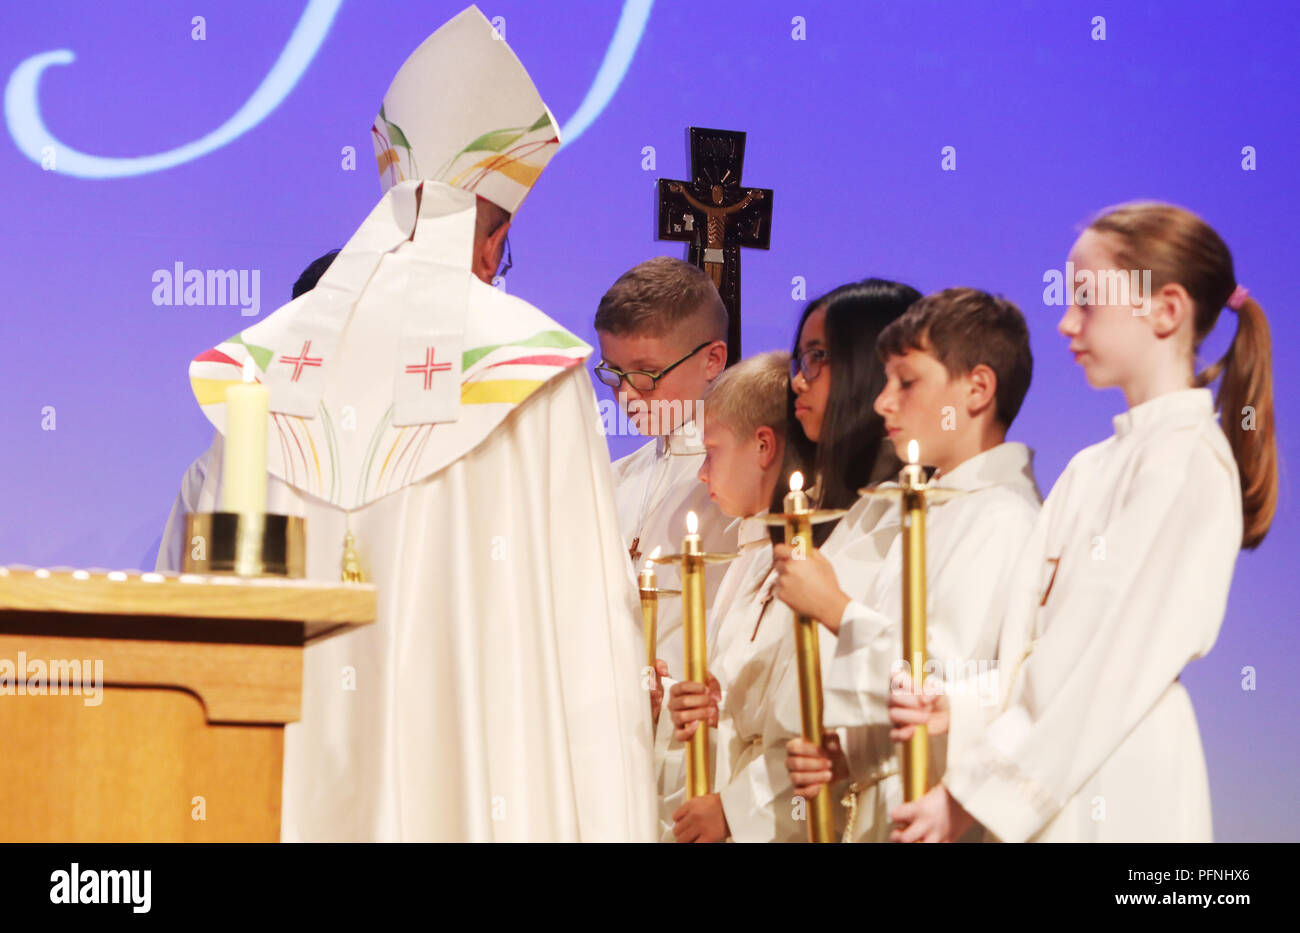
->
xmin=159 ymin=279 xmax=655 ymax=841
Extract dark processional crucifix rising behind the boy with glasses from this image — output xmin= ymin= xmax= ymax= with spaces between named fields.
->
xmin=659 ymin=126 xmax=772 ymax=365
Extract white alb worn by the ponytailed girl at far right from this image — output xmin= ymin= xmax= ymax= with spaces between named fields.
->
xmin=944 ymin=389 xmax=1242 ymax=842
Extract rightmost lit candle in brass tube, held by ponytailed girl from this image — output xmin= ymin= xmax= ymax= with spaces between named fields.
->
xmin=898 ymin=441 xmax=930 ymax=800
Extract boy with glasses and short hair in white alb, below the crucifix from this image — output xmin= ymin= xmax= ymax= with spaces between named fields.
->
xmin=595 ymin=256 xmax=736 ymax=677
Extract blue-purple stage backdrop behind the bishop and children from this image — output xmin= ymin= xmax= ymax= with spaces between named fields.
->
xmin=0 ymin=0 xmax=1300 ymax=839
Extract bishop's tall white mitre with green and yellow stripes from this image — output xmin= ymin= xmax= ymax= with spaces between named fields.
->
xmin=371 ymin=6 xmax=560 ymax=213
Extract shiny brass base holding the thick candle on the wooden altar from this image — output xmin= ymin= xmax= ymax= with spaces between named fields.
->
xmin=183 ymin=512 xmax=307 ymax=578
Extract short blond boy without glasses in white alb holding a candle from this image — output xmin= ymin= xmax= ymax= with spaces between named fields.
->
xmin=659 ymin=352 xmax=847 ymax=842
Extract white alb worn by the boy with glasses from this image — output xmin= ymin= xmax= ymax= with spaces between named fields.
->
xmin=614 ymin=421 xmax=736 ymax=681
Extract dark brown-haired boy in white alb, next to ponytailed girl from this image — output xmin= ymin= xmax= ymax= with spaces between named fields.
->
xmin=776 ymin=288 xmax=1041 ymax=841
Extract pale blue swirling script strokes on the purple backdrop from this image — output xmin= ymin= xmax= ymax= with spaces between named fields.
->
xmin=4 ymin=0 xmax=654 ymax=178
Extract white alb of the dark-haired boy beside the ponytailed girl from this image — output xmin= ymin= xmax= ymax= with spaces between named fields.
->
xmin=824 ymin=443 xmax=1041 ymax=842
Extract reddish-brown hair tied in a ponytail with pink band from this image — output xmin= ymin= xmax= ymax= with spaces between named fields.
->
xmin=1089 ymin=201 xmax=1278 ymax=548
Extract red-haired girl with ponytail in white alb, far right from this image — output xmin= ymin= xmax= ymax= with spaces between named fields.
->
xmin=891 ymin=203 xmax=1278 ymax=842
